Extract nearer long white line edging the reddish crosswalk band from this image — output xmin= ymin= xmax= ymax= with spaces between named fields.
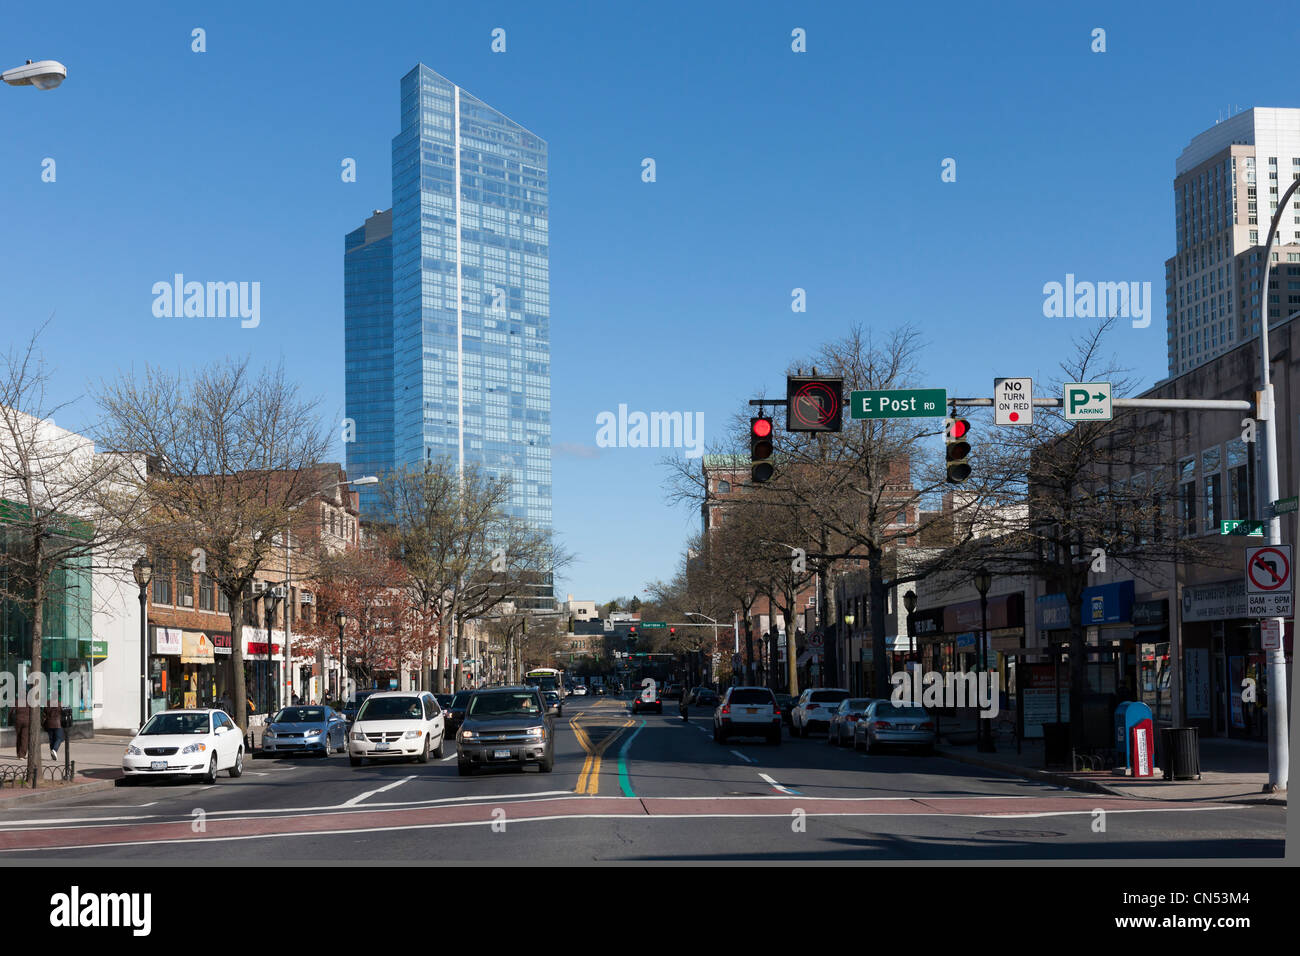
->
xmin=0 ymin=806 xmax=1252 ymax=853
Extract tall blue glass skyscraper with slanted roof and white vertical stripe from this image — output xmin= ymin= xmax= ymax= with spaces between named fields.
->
xmin=345 ymin=64 xmax=551 ymax=529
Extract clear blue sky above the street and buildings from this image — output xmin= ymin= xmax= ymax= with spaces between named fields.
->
xmin=0 ymin=1 xmax=1279 ymax=600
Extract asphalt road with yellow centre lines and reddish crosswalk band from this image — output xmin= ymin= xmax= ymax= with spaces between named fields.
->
xmin=0 ymin=698 xmax=1286 ymax=864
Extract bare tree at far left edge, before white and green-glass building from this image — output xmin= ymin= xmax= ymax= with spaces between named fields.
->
xmin=0 ymin=330 xmax=150 ymax=783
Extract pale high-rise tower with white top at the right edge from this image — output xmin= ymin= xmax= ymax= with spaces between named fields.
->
xmin=1165 ymin=107 xmax=1300 ymax=377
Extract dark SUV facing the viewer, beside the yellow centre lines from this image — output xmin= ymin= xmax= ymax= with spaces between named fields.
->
xmin=456 ymin=687 xmax=555 ymax=777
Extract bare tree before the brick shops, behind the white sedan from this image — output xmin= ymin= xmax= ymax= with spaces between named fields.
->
xmin=99 ymin=359 xmax=332 ymax=728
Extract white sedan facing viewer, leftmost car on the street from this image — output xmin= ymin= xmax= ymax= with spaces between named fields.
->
xmin=122 ymin=710 xmax=244 ymax=783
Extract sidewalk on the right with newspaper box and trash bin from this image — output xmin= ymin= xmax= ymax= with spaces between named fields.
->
xmin=935 ymin=717 xmax=1287 ymax=806
